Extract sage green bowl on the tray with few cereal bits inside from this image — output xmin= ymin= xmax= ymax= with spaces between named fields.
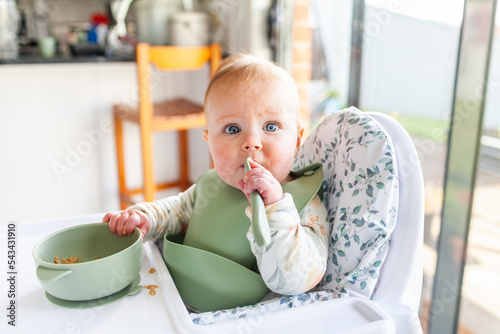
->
xmin=33 ymin=223 xmax=142 ymax=301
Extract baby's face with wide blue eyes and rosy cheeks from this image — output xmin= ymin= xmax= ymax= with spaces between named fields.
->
xmin=204 ymin=78 xmax=302 ymax=188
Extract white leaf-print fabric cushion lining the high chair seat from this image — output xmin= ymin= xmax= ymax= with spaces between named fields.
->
xmin=191 ymin=107 xmax=399 ymax=324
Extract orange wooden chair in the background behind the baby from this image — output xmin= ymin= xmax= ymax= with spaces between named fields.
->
xmin=113 ymin=43 xmax=221 ymax=209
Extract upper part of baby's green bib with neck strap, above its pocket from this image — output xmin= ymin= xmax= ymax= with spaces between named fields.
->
xmin=184 ymin=164 xmax=323 ymax=268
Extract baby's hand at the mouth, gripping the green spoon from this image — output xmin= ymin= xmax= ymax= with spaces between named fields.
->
xmin=238 ymin=161 xmax=283 ymax=205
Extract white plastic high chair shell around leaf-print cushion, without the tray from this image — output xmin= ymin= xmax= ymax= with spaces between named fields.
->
xmin=156 ymin=112 xmax=424 ymax=334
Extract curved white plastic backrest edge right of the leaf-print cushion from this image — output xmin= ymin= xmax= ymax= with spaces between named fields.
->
xmin=368 ymin=112 xmax=424 ymax=312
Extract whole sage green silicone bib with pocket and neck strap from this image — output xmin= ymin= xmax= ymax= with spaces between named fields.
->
xmin=163 ymin=164 xmax=323 ymax=312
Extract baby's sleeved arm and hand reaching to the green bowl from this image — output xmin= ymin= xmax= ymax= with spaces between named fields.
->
xmin=103 ymin=185 xmax=195 ymax=241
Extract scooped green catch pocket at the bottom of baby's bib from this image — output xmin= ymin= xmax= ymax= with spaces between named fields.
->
xmin=163 ymin=235 xmax=268 ymax=312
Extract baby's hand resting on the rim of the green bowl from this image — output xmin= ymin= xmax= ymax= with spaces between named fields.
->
xmin=102 ymin=209 xmax=151 ymax=239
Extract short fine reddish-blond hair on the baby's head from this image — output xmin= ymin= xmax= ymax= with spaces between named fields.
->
xmin=205 ymin=54 xmax=300 ymax=122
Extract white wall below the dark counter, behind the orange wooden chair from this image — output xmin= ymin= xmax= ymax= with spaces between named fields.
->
xmin=0 ymin=62 xmax=210 ymax=222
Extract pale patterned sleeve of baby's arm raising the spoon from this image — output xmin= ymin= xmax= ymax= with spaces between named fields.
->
xmin=246 ymin=193 xmax=328 ymax=295
